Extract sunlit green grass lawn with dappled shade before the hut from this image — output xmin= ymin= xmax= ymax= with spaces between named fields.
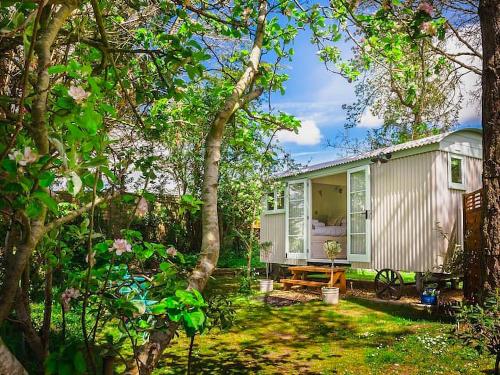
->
xmin=155 ymin=278 xmax=494 ymax=374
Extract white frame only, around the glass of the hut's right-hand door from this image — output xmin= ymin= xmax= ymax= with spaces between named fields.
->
xmin=347 ymin=165 xmax=371 ymax=262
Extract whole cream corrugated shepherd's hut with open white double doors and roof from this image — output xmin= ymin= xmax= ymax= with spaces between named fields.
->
xmin=260 ymin=128 xmax=482 ymax=272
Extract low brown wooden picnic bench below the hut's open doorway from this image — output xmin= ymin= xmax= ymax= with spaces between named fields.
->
xmin=280 ymin=266 xmax=346 ymax=293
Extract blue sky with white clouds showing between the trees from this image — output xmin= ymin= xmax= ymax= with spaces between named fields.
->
xmin=272 ymin=27 xmax=480 ymax=164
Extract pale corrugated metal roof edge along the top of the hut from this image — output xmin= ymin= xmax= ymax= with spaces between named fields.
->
xmin=276 ymin=128 xmax=482 ymax=178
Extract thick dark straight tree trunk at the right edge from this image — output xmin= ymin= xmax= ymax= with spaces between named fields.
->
xmin=479 ymin=0 xmax=500 ymax=292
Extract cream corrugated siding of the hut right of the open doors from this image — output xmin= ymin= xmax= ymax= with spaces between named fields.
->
xmin=372 ymin=151 xmax=481 ymax=272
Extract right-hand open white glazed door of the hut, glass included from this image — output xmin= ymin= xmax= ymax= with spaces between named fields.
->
xmin=347 ymin=165 xmax=371 ymax=262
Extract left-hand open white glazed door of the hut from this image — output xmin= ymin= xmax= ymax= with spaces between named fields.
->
xmin=286 ymin=180 xmax=308 ymax=259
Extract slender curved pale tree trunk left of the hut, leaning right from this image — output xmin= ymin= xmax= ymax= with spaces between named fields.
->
xmin=126 ymin=0 xmax=267 ymax=375
